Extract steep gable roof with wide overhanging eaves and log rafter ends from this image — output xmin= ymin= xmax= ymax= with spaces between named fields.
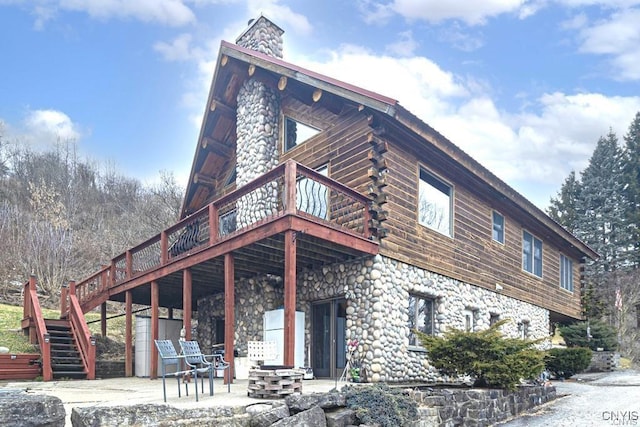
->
xmin=182 ymin=41 xmax=598 ymax=259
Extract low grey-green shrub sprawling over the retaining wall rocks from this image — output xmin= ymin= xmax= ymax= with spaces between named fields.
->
xmin=343 ymin=384 xmax=418 ymax=427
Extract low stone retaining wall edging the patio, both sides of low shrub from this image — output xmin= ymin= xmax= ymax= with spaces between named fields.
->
xmin=66 ymin=386 xmax=556 ymax=427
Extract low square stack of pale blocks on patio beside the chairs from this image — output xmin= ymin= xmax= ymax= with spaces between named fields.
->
xmin=247 ymin=369 xmax=304 ymax=398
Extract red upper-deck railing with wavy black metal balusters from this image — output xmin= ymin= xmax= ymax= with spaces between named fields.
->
xmin=70 ymin=160 xmax=370 ymax=310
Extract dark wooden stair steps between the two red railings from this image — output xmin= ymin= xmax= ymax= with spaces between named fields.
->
xmin=44 ymin=319 xmax=87 ymax=379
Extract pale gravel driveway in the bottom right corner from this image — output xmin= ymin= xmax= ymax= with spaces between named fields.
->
xmin=500 ymin=370 xmax=640 ymax=427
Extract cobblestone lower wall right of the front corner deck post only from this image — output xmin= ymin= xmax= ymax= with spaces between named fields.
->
xmin=298 ymin=255 xmax=549 ymax=382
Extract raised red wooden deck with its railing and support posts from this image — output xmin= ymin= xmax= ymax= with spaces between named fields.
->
xmin=75 ymin=161 xmax=378 ymax=378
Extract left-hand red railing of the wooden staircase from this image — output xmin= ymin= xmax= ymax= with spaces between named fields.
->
xmin=22 ymin=276 xmax=53 ymax=381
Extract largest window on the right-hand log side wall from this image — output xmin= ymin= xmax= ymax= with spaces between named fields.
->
xmin=418 ymin=168 xmax=453 ymax=236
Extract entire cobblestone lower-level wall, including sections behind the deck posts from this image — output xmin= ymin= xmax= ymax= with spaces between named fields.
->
xmin=198 ymin=255 xmax=550 ymax=382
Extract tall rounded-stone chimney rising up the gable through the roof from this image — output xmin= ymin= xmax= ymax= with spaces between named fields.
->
xmin=236 ymin=16 xmax=284 ymax=227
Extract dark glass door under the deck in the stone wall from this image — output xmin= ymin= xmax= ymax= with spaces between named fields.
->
xmin=311 ymin=299 xmax=347 ymax=378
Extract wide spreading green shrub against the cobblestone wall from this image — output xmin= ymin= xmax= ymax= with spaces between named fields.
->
xmin=416 ymin=319 xmax=544 ymax=390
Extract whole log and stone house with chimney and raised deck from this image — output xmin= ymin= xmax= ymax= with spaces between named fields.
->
xmin=22 ymin=16 xmax=597 ymax=382
